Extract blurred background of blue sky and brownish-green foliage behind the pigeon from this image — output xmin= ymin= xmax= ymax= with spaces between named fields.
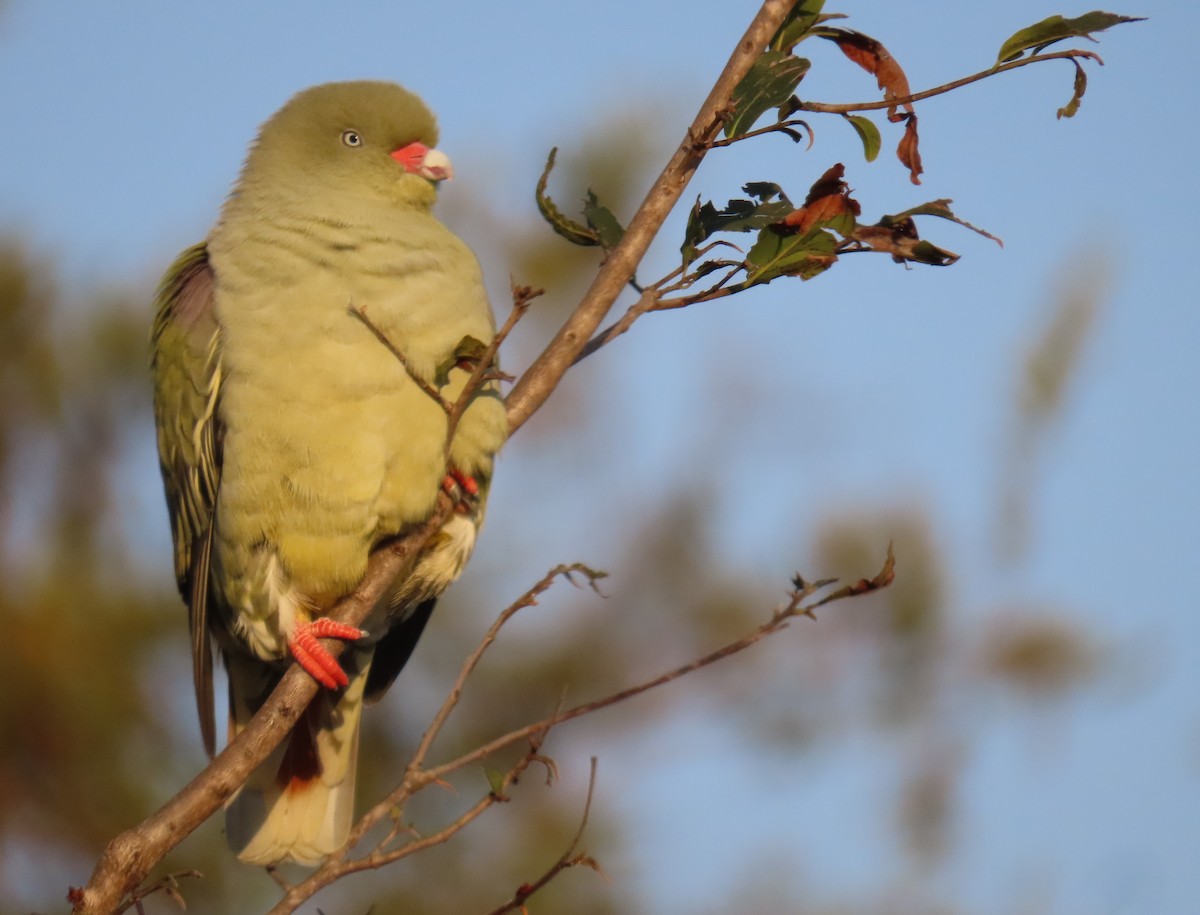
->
xmin=0 ymin=0 xmax=1200 ymax=915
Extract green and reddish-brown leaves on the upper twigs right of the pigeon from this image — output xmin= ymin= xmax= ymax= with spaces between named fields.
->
xmin=536 ymin=0 xmax=1138 ymax=321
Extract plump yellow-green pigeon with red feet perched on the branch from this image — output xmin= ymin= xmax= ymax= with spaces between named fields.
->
xmin=152 ymin=82 xmax=508 ymax=866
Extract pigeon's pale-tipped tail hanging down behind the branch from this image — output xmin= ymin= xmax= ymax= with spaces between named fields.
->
xmin=226 ymin=651 xmax=371 ymax=867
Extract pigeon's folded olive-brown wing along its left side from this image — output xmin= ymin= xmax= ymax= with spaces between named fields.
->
xmin=151 ymin=243 xmax=222 ymax=756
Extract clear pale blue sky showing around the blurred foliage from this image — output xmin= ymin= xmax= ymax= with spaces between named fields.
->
xmin=0 ymin=0 xmax=1200 ymax=915
